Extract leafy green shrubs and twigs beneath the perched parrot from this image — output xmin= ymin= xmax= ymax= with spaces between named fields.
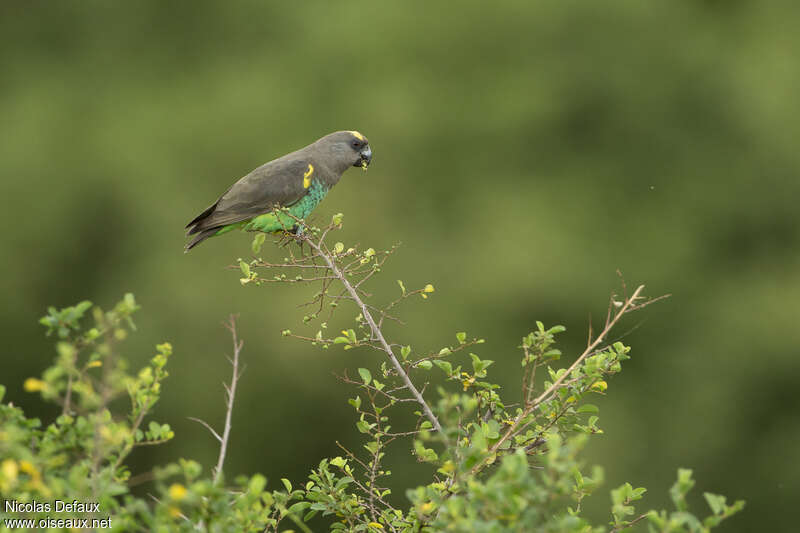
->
xmin=0 ymin=222 xmax=744 ymax=532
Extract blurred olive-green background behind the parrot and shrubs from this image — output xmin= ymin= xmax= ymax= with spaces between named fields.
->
xmin=0 ymin=0 xmax=800 ymax=531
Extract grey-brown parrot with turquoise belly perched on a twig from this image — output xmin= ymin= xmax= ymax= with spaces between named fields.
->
xmin=185 ymin=131 xmax=372 ymax=252
